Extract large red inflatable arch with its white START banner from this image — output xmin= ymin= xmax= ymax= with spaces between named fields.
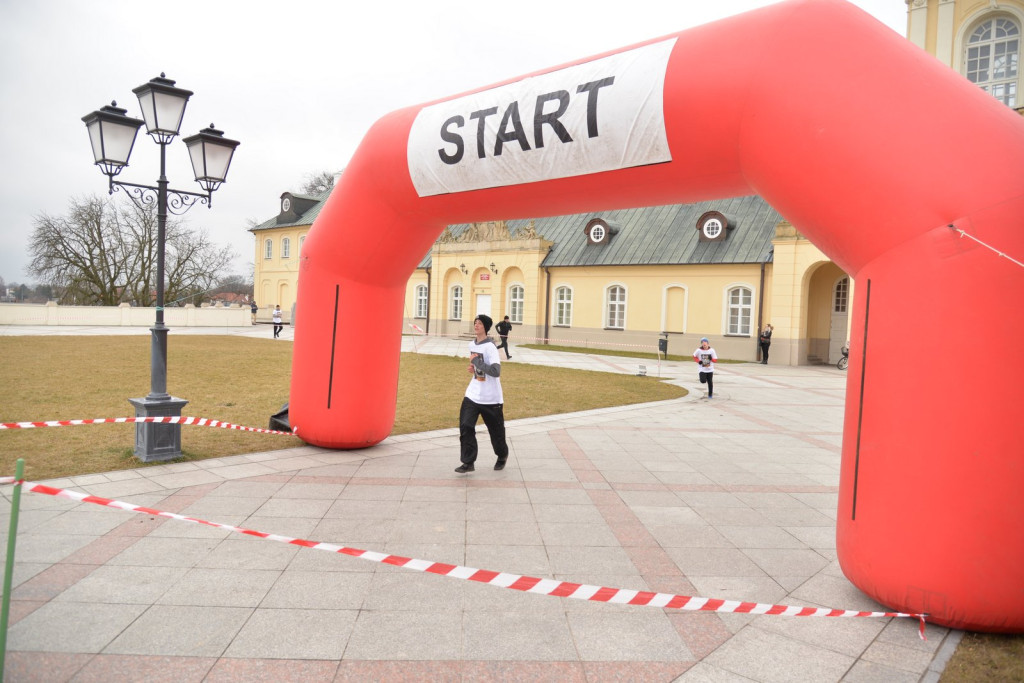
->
xmin=290 ymin=0 xmax=1024 ymax=632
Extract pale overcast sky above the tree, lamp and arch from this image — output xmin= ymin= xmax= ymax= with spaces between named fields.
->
xmin=0 ymin=0 xmax=906 ymax=284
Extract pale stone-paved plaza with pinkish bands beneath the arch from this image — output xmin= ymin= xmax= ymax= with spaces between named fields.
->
xmin=0 ymin=328 xmax=961 ymax=682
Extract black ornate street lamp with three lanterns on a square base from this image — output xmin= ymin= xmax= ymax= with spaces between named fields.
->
xmin=82 ymin=74 xmax=239 ymax=462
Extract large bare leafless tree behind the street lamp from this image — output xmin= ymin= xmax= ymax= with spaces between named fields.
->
xmin=29 ymin=197 xmax=234 ymax=305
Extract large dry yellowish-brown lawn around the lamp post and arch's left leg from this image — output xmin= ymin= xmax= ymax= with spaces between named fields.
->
xmin=0 ymin=336 xmax=686 ymax=479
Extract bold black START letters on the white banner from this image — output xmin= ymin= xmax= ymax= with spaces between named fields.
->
xmin=437 ymin=76 xmax=615 ymax=165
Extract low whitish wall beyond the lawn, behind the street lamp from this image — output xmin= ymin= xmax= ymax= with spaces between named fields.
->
xmin=0 ymin=301 xmax=252 ymax=328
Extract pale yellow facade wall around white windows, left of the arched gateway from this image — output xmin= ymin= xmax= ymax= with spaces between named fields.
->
xmin=403 ymin=258 xmax=771 ymax=360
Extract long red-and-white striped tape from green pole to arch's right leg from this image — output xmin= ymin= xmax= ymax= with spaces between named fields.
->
xmin=2 ymin=479 xmax=928 ymax=639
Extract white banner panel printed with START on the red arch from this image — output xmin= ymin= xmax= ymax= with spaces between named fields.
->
xmin=407 ymin=38 xmax=676 ymax=197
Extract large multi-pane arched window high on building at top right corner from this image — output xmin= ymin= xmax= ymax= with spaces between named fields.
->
xmin=964 ymin=15 xmax=1021 ymax=108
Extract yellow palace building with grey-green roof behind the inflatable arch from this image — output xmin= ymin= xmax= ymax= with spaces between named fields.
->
xmin=250 ymin=0 xmax=1024 ymax=365
